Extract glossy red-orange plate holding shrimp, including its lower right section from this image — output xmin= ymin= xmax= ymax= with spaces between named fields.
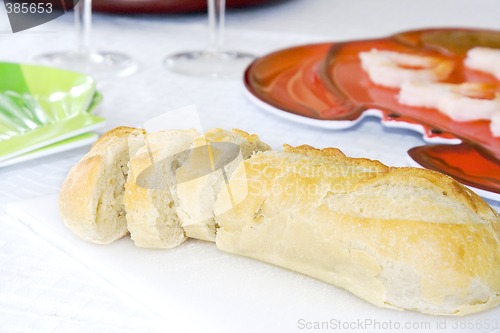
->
xmin=244 ymin=29 xmax=500 ymax=200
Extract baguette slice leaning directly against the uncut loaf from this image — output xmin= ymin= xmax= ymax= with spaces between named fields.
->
xmin=174 ymin=129 xmax=270 ymax=241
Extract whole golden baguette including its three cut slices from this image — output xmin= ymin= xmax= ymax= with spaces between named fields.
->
xmin=59 ymin=127 xmax=500 ymax=315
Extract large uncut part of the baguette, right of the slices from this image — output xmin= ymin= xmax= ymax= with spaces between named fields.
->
xmin=215 ymin=146 xmax=500 ymax=315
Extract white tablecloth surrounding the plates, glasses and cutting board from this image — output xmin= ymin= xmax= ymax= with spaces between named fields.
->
xmin=0 ymin=0 xmax=500 ymax=332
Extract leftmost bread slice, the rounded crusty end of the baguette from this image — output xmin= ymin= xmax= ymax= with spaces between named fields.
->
xmin=59 ymin=127 xmax=143 ymax=244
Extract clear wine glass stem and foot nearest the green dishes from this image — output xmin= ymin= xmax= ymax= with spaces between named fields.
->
xmin=35 ymin=0 xmax=137 ymax=78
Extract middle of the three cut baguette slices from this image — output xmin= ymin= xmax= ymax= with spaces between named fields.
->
xmin=123 ymin=130 xmax=200 ymax=248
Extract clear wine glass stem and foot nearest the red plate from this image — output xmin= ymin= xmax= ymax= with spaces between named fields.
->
xmin=163 ymin=0 xmax=255 ymax=77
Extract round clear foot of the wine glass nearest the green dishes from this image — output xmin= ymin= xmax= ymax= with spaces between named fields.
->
xmin=35 ymin=52 xmax=137 ymax=78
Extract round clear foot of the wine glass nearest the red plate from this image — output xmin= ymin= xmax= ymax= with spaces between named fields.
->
xmin=163 ymin=51 xmax=255 ymax=77
